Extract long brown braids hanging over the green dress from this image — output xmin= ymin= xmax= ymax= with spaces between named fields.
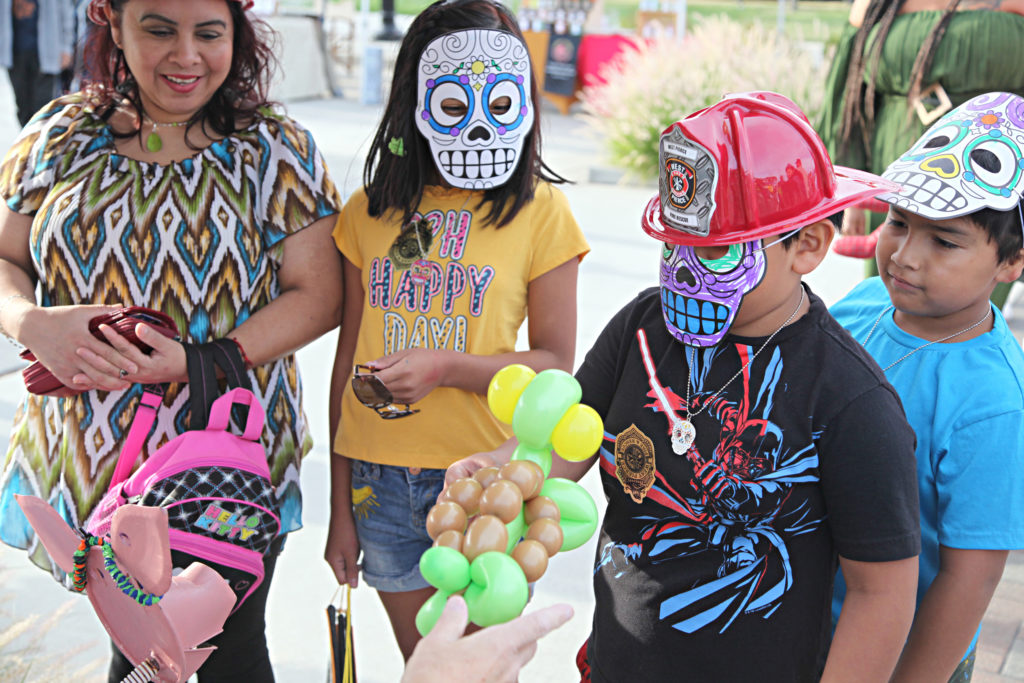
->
xmin=839 ymin=0 xmax=961 ymax=166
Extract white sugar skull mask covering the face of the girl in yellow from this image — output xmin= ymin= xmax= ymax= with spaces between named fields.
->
xmin=416 ymin=29 xmax=535 ymax=189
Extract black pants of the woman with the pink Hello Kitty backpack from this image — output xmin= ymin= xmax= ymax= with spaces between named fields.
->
xmin=106 ymin=537 xmax=284 ymax=683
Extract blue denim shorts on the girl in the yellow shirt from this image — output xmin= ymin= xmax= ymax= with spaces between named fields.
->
xmin=352 ymin=460 xmax=444 ymax=593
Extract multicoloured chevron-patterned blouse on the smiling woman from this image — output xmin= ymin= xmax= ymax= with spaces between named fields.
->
xmin=0 ymin=94 xmax=340 ymax=578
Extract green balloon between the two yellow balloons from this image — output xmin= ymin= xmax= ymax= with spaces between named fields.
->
xmin=512 ymin=370 xmax=583 ymax=450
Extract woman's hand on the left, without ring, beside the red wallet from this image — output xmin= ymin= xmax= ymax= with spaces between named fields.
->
xmin=18 ymin=305 xmax=130 ymax=391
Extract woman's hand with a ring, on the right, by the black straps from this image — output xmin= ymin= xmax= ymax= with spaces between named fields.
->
xmin=75 ymin=323 xmax=188 ymax=386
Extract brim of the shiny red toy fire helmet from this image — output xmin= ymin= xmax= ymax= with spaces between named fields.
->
xmin=640 ymin=166 xmax=899 ymax=247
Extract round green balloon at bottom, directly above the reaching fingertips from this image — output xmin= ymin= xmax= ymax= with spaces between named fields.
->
xmin=465 ymin=551 xmax=529 ymax=627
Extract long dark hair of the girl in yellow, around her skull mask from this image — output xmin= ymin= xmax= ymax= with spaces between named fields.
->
xmin=362 ymin=0 xmax=566 ymax=227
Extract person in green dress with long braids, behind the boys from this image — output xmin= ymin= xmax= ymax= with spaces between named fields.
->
xmin=817 ymin=0 xmax=1024 ymax=305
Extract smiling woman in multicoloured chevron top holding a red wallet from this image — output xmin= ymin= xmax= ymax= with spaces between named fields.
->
xmin=0 ymin=0 xmax=341 ymax=681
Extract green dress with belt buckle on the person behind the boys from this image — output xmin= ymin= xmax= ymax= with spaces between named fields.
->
xmin=817 ymin=10 xmax=1024 ymax=307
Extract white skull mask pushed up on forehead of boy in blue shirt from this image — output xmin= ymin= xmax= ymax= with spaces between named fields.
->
xmin=879 ymin=92 xmax=1024 ymax=220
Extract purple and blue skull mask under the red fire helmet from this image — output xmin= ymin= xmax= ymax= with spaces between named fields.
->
xmin=662 ymin=240 xmax=765 ymax=346
